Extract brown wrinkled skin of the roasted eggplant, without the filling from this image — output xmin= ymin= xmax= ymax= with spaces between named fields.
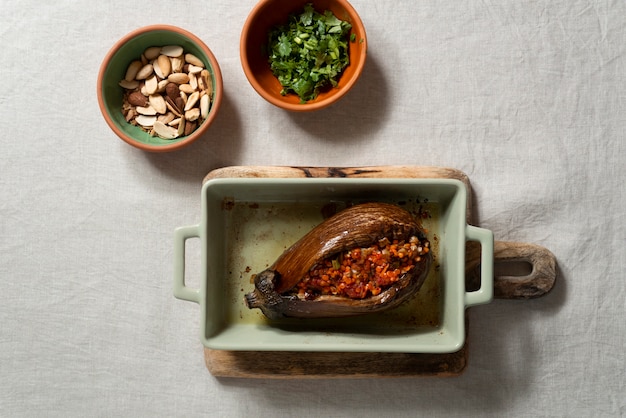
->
xmin=245 ymin=203 xmax=432 ymax=319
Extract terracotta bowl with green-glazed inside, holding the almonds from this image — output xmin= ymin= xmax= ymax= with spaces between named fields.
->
xmin=97 ymin=25 xmax=224 ymax=152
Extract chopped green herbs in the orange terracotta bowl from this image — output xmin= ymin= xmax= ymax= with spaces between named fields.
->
xmin=268 ymin=3 xmax=355 ymax=103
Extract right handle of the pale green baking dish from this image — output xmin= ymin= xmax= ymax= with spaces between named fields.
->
xmin=465 ymin=225 xmax=493 ymax=307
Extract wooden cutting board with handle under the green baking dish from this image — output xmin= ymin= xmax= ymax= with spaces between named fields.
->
xmin=197 ymin=166 xmax=556 ymax=379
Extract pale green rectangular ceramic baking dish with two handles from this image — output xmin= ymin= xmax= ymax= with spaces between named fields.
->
xmin=174 ymin=178 xmax=494 ymax=353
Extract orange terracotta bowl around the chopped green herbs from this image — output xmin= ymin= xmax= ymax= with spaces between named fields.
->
xmin=240 ymin=0 xmax=367 ymax=112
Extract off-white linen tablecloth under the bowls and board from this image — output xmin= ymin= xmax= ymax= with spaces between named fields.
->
xmin=0 ymin=0 xmax=626 ymax=417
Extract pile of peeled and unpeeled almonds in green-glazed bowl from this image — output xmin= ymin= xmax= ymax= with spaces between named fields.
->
xmin=119 ymin=45 xmax=213 ymax=139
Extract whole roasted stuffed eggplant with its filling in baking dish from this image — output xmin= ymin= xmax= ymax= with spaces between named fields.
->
xmin=245 ymin=203 xmax=432 ymax=319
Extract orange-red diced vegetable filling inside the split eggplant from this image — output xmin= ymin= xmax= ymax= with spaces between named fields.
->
xmin=294 ymin=236 xmax=430 ymax=300
